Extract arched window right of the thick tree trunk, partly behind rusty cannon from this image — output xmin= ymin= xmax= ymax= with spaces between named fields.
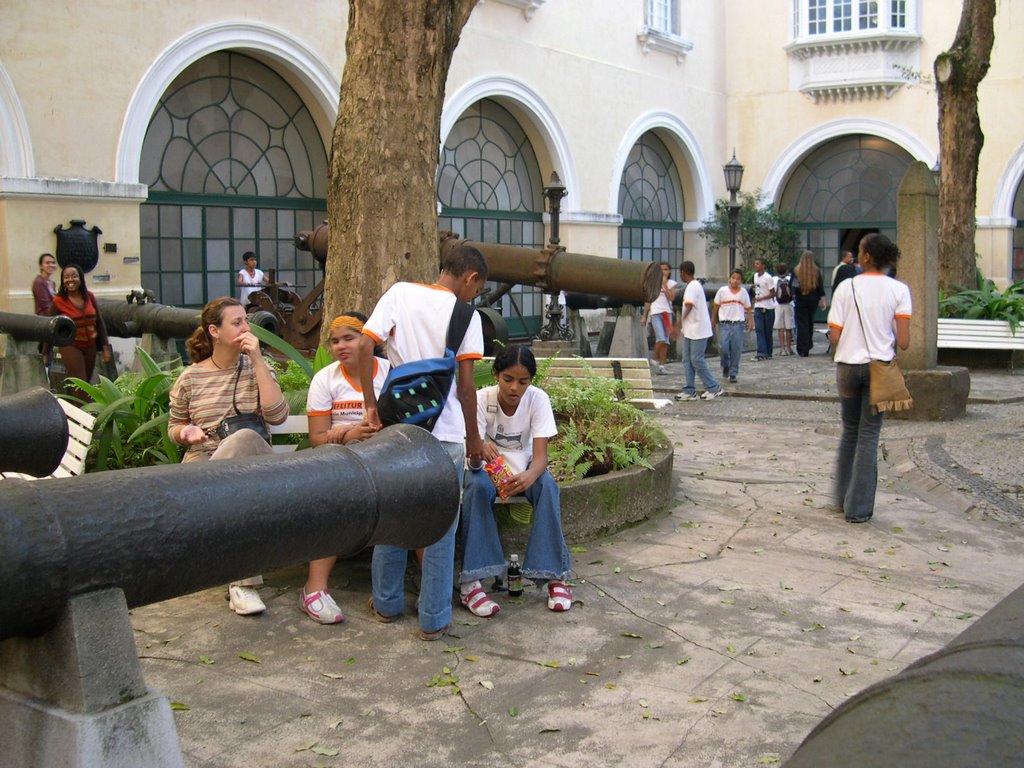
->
xmin=437 ymin=98 xmax=544 ymax=336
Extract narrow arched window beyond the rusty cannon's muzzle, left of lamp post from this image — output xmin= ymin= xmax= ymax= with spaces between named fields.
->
xmin=618 ymin=131 xmax=685 ymax=267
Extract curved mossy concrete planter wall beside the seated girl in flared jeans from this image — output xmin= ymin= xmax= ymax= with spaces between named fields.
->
xmin=496 ymin=443 xmax=673 ymax=554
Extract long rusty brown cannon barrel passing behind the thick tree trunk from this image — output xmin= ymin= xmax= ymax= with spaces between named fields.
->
xmin=295 ymin=224 xmax=662 ymax=304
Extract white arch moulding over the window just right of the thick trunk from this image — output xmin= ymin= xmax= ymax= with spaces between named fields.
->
xmin=440 ymin=75 xmax=580 ymax=212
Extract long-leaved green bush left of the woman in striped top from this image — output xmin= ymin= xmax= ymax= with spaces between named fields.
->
xmin=68 ymin=347 xmax=182 ymax=472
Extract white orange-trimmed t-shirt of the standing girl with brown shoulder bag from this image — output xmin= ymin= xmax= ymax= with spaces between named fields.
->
xmin=828 ymin=272 xmax=911 ymax=366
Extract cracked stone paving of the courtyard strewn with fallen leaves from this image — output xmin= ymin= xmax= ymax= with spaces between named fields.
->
xmin=132 ymin=331 xmax=1024 ymax=768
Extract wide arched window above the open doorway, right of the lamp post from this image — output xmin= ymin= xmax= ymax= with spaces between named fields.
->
xmin=778 ymin=134 xmax=913 ymax=283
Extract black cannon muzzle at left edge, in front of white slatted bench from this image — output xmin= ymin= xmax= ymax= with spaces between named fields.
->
xmin=0 ymin=387 xmax=68 ymax=479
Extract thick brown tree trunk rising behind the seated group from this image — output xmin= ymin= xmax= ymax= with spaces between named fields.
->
xmin=323 ymin=0 xmax=477 ymax=333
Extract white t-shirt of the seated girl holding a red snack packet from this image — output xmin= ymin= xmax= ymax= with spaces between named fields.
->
xmin=476 ymin=384 xmax=558 ymax=474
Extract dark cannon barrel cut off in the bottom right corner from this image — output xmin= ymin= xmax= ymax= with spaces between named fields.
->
xmin=785 ymin=587 xmax=1024 ymax=768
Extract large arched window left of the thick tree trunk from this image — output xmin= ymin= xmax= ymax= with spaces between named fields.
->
xmin=139 ymin=51 xmax=327 ymax=306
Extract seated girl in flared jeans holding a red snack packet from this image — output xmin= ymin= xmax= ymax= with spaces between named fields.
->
xmin=459 ymin=345 xmax=572 ymax=617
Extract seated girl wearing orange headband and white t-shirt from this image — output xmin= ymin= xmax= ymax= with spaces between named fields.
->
xmin=299 ymin=312 xmax=391 ymax=624
